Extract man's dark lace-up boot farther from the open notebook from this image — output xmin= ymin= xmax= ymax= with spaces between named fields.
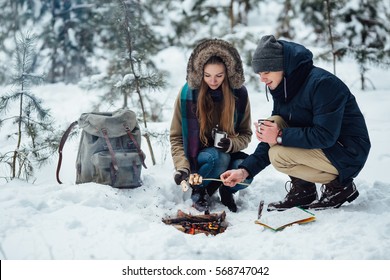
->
xmin=307 ymin=179 xmax=359 ymax=210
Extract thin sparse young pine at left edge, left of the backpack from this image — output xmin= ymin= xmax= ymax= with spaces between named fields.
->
xmin=0 ymin=34 xmax=56 ymax=180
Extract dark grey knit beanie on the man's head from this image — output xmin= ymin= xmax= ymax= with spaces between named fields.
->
xmin=252 ymin=35 xmax=283 ymax=73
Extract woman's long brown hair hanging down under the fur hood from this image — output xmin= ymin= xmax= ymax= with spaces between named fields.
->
xmin=196 ymin=56 xmax=237 ymax=146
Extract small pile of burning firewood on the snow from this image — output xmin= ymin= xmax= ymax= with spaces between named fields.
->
xmin=162 ymin=210 xmax=227 ymax=235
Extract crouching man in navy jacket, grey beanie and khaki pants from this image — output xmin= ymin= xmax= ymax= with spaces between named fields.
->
xmin=220 ymin=35 xmax=371 ymax=211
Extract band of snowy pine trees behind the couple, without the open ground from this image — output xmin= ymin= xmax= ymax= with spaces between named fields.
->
xmin=0 ymin=0 xmax=390 ymax=184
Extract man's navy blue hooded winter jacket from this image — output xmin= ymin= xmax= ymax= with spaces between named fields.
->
xmin=239 ymin=40 xmax=371 ymax=183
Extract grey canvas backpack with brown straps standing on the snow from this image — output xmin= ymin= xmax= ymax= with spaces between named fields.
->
xmin=56 ymin=109 xmax=146 ymax=188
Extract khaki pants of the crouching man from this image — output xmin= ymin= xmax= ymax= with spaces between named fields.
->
xmin=268 ymin=116 xmax=339 ymax=184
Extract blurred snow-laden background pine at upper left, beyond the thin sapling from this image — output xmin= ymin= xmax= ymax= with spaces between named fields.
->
xmin=39 ymin=0 xmax=99 ymax=83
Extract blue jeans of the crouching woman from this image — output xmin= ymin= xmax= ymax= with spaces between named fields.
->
xmin=198 ymin=147 xmax=253 ymax=192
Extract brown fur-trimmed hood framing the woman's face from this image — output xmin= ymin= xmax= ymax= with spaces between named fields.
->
xmin=187 ymin=39 xmax=245 ymax=89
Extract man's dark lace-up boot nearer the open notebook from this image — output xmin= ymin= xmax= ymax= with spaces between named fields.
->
xmin=267 ymin=176 xmax=318 ymax=211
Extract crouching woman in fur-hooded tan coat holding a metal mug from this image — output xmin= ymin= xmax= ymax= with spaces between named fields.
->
xmin=170 ymin=39 xmax=252 ymax=212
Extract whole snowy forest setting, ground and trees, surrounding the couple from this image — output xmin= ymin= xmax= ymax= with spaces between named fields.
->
xmin=0 ymin=0 xmax=390 ymax=264
